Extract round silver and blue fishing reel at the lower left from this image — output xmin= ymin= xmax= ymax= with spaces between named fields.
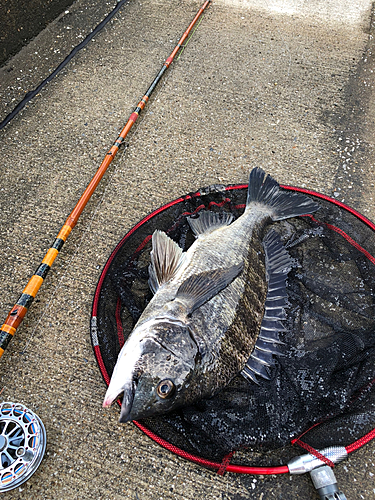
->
xmin=0 ymin=402 xmax=46 ymax=492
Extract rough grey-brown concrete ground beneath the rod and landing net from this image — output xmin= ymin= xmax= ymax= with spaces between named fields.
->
xmin=0 ymin=0 xmax=375 ymax=500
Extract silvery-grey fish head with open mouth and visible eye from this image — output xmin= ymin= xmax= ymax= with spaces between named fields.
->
xmin=104 ymin=318 xmax=199 ymax=423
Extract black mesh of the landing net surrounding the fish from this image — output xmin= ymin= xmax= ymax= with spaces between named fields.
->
xmin=92 ymin=186 xmax=375 ymax=463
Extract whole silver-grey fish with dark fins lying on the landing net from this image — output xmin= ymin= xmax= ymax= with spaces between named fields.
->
xmin=103 ymin=167 xmax=319 ymax=423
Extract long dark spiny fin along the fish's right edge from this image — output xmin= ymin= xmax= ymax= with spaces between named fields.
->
xmin=241 ymin=230 xmax=292 ymax=384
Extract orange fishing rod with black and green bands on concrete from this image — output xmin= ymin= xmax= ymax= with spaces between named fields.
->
xmin=0 ymin=0 xmax=211 ymax=357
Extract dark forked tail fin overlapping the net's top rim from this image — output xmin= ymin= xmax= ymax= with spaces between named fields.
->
xmin=246 ymin=167 xmax=319 ymax=221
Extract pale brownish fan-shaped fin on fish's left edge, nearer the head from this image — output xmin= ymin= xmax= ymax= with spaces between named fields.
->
xmin=148 ymin=231 xmax=184 ymax=293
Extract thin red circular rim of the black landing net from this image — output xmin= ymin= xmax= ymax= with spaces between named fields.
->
xmin=91 ymin=184 xmax=375 ymax=475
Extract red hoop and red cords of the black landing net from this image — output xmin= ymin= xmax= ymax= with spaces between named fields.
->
xmin=91 ymin=184 xmax=375 ymax=475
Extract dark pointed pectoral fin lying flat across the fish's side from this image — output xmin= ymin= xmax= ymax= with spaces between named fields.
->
xmin=175 ymin=263 xmax=243 ymax=315
